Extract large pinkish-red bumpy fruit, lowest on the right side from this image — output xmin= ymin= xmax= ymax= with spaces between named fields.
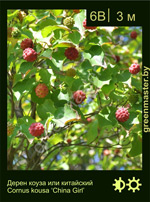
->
xmin=116 ymin=107 xmax=130 ymax=122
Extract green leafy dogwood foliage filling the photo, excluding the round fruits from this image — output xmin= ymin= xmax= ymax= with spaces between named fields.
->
xmin=7 ymin=10 xmax=142 ymax=170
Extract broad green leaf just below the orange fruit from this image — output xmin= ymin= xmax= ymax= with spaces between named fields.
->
xmin=37 ymin=100 xmax=56 ymax=119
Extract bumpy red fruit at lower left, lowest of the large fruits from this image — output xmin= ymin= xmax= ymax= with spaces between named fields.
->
xmin=29 ymin=123 xmax=44 ymax=137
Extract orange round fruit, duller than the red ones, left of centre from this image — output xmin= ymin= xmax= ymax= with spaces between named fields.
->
xmin=35 ymin=83 xmax=49 ymax=98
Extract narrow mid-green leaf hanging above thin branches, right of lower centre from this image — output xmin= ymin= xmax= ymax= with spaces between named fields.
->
xmin=86 ymin=120 xmax=98 ymax=144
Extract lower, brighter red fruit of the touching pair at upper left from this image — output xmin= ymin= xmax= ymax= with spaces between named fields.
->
xmin=23 ymin=48 xmax=37 ymax=62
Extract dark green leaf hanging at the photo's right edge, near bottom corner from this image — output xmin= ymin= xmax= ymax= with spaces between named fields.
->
xmin=128 ymin=133 xmax=142 ymax=157
